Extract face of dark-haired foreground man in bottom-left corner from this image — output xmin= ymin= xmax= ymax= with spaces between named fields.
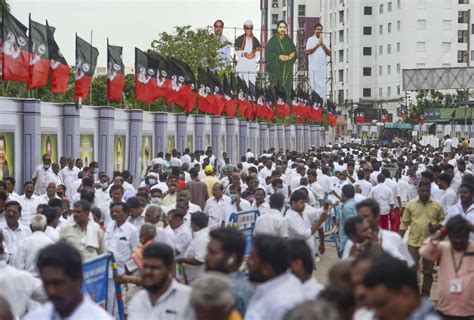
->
xmin=40 ymin=266 xmax=82 ymax=310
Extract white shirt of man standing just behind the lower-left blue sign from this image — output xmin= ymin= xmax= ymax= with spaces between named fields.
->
xmin=104 ymin=221 xmax=138 ymax=274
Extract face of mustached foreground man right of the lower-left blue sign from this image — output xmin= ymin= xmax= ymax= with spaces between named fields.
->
xmin=141 ymin=258 xmax=173 ymax=292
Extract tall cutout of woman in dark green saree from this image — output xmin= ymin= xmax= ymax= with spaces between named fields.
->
xmin=266 ymin=20 xmax=296 ymax=97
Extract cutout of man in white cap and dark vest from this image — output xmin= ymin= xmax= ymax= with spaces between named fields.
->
xmin=234 ymin=20 xmax=262 ymax=84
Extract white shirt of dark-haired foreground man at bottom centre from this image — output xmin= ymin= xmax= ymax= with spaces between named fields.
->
xmin=245 ymin=272 xmax=305 ymax=320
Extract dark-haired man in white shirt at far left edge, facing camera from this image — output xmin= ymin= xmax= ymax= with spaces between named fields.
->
xmin=0 ymin=201 xmax=31 ymax=267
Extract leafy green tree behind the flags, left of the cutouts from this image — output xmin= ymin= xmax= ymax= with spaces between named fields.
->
xmin=151 ymin=26 xmax=230 ymax=72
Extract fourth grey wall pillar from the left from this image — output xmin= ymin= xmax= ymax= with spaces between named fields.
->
xmin=127 ymin=109 xmax=143 ymax=187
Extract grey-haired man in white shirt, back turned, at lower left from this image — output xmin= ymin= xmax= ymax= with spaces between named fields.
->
xmin=17 ymin=214 xmax=54 ymax=277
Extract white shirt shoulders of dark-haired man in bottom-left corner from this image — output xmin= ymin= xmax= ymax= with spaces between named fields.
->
xmin=23 ymin=295 xmax=114 ymax=320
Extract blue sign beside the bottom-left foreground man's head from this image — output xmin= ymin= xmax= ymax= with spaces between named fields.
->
xmin=82 ymin=253 xmax=111 ymax=309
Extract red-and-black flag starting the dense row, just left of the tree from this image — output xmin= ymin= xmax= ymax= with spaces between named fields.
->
xmin=135 ymin=48 xmax=158 ymax=103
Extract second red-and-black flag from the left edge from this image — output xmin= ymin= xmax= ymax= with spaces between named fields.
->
xmin=28 ymin=17 xmax=50 ymax=89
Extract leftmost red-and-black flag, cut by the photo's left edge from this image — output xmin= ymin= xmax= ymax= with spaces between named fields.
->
xmin=2 ymin=10 xmax=30 ymax=82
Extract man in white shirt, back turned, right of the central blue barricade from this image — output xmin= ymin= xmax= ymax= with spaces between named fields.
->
xmin=253 ymin=193 xmax=288 ymax=238
